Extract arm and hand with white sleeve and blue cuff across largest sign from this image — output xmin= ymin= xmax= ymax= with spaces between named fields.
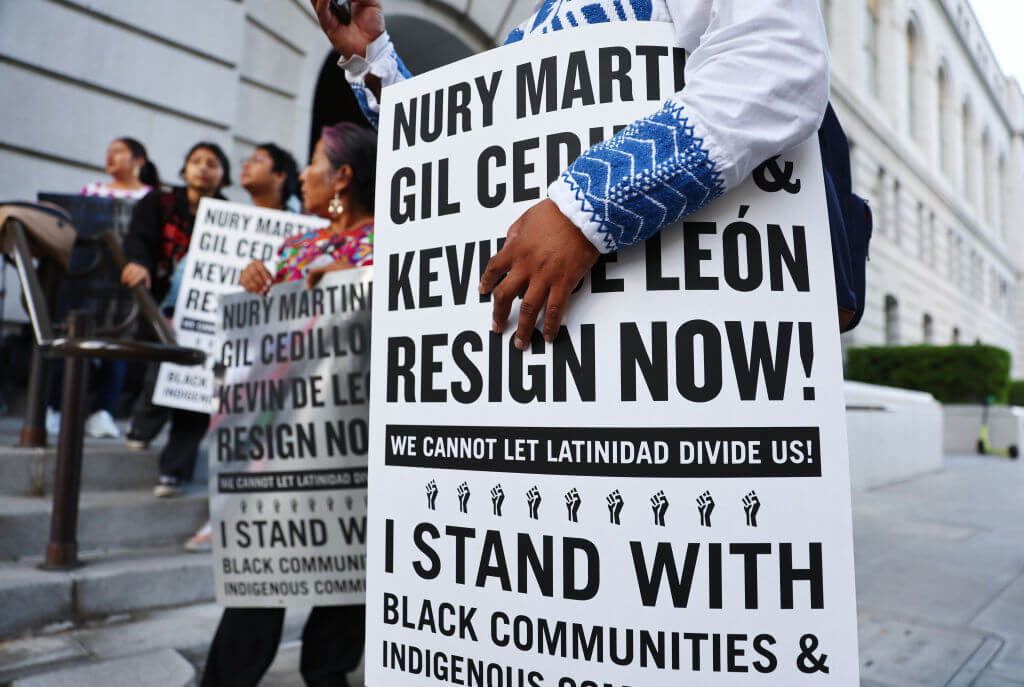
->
xmin=480 ymin=0 xmax=828 ymax=350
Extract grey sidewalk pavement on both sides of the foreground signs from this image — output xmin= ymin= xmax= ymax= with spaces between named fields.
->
xmin=0 ymin=456 xmax=1024 ymax=687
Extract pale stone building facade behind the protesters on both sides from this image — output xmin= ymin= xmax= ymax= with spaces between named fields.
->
xmin=0 ymin=0 xmax=1024 ymax=374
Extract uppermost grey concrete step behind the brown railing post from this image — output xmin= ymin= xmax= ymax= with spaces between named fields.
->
xmin=0 ymin=444 xmax=160 ymax=497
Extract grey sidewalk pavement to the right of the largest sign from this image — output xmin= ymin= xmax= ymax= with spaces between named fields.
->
xmin=853 ymin=456 xmax=1024 ymax=687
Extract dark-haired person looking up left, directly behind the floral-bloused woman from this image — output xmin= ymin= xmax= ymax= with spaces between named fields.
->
xmin=185 ymin=143 xmax=302 ymax=553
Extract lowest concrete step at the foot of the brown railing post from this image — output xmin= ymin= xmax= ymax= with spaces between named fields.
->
xmin=0 ymin=548 xmax=214 ymax=638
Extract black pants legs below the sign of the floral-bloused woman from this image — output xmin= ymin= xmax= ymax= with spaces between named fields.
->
xmin=201 ymin=606 xmax=367 ymax=687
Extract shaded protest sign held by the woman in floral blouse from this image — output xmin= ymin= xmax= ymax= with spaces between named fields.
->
xmin=207 ymin=268 xmax=373 ymax=607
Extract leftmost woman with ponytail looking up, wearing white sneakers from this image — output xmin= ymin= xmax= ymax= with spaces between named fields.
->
xmin=46 ymin=136 xmax=160 ymax=438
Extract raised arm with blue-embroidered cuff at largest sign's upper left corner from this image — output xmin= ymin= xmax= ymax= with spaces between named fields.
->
xmin=312 ymin=0 xmax=412 ymax=129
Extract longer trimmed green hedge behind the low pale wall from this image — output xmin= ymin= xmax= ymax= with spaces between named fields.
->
xmin=846 ymin=344 xmax=1011 ymax=403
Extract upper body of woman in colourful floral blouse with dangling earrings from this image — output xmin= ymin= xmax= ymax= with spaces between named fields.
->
xmin=240 ymin=122 xmax=377 ymax=295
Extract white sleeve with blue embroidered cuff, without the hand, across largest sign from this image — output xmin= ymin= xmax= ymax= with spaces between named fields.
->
xmin=548 ymin=0 xmax=828 ymax=253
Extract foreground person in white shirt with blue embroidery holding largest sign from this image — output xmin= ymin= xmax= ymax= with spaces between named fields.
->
xmin=311 ymin=0 xmax=828 ymax=339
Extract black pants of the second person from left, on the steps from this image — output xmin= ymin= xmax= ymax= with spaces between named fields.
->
xmin=128 ymin=362 xmax=210 ymax=482
